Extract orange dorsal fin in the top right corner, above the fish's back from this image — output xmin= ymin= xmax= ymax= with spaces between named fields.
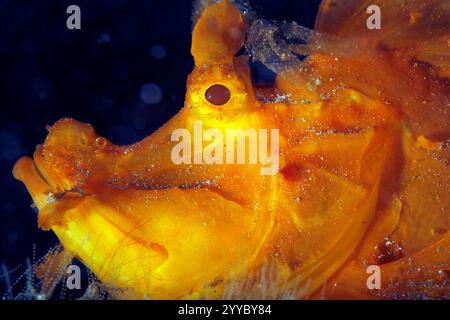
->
xmin=315 ymin=0 xmax=450 ymax=78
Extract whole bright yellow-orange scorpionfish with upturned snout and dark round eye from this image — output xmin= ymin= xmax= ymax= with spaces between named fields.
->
xmin=13 ymin=0 xmax=450 ymax=299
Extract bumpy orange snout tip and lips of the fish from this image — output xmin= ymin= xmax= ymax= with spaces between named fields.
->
xmin=13 ymin=119 xmax=103 ymax=220
